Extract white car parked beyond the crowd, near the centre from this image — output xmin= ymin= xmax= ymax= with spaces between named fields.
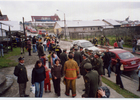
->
xmin=72 ymin=40 xmax=100 ymax=53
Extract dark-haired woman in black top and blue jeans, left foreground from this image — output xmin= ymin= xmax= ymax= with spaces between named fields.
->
xmin=31 ymin=60 xmax=46 ymax=97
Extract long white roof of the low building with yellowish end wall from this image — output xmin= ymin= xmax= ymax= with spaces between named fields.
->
xmin=56 ymin=20 xmax=108 ymax=27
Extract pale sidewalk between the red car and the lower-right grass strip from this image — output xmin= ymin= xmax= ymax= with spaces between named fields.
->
xmin=103 ymin=71 xmax=140 ymax=96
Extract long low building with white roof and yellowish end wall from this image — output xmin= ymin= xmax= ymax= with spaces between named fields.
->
xmin=54 ymin=20 xmax=114 ymax=35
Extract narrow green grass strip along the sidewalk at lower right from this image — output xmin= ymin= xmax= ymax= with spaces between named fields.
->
xmin=102 ymin=77 xmax=140 ymax=98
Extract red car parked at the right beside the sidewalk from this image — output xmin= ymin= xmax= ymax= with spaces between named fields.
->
xmin=109 ymin=49 xmax=140 ymax=71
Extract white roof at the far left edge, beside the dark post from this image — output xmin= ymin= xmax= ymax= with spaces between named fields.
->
xmin=0 ymin=21 xmax=21 ymax=31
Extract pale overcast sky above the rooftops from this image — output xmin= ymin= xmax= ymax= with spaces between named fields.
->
xmin=0 ymin=0 xmax=140 ymax=21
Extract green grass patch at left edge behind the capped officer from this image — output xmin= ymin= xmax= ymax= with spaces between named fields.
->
xmin=0 ymin=48 xmax=21 ymax=68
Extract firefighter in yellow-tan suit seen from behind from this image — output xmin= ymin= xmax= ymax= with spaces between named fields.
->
xmin=64 ymin=55 xmax=79 ymax=97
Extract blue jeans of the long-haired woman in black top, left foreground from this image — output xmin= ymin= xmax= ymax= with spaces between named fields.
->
xmin=35 ymin=81 xmax=44 ymax=97
